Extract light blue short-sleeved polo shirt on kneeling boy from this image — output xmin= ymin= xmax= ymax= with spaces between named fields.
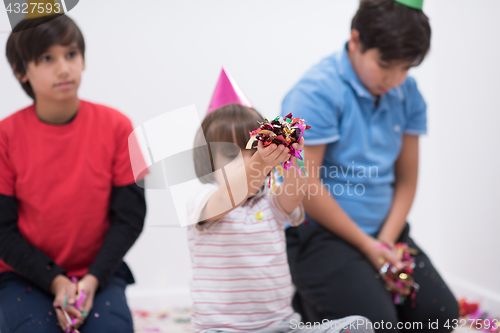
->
xmin=281 ymin=44 xmax=427 ymax=236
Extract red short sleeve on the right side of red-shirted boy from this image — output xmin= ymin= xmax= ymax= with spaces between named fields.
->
xmin=112 ymin=116 xmax=149 ymax=186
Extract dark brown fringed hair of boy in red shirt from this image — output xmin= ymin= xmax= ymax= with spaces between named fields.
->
xmin=6 ymin=14 xmax=85 ymax=99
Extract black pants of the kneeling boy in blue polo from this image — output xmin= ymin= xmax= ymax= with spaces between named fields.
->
xmin=286 ymin=220 xmax=459 ymax=333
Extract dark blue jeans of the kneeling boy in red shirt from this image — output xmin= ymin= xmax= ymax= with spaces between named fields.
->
xmin=0 ymin=267 xmax=134 ymax=333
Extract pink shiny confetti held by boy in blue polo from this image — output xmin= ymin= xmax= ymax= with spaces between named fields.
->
xmin=380 ymin=243 xmax=419 ymax=307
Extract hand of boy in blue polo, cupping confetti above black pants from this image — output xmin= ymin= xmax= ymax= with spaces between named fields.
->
xmin=362 ymin=238 xmax=410 ymax=295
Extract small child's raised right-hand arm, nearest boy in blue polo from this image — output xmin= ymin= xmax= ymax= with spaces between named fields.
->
xmin=276 ymin=138 xmax=307 ymax=214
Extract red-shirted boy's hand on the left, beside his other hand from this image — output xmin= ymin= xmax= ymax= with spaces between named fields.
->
xmin=50 ymin=275 xmax=82 ymax=331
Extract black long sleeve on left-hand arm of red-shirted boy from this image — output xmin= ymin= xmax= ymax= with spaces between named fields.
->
xmin=0 ymin=194 xmax=66 ymax=293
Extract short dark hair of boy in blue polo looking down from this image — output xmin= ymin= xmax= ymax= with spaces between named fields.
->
xmin=351 ymin=0 xmax=431 ymax=66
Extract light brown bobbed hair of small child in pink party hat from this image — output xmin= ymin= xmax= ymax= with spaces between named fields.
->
xmin=193 ymin=104 xmax=263 ymax=183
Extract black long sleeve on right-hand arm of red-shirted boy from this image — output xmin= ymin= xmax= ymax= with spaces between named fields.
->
xmin=87 ymin=179 xmax=146 ymax=289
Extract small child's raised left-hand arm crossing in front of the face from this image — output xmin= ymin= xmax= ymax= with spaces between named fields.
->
xmin=200 ymin=141 xmax=289 ymax=221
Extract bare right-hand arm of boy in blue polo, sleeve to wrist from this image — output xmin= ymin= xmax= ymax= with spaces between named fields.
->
xmin=378 ymin=134 xmax=418 ymax=245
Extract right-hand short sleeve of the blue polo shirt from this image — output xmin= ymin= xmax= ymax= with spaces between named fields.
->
xmin=403 ymin=77 xmax=427 ymax=135
